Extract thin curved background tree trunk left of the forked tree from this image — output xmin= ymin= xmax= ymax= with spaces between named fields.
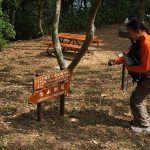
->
xmin=38 ymin=0 xmax=45 ymax=35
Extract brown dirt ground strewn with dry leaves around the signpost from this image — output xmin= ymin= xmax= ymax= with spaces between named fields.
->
xmin=0 ymin=24 xmax=150 ymax=150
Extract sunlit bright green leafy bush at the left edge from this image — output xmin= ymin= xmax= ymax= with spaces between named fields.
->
xmin=0 ymin=0 xmax=15 ymax=49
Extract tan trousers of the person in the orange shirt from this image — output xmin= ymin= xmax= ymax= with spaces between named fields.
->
xmin=130 ymin=77 xmax=150 ymax=126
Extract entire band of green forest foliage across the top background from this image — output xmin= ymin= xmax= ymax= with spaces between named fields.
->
xmin=0 ymin=0 xmax=150 ymax=39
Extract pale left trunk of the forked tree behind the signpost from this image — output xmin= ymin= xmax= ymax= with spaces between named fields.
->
xmin=52 ymin=0 xmax=66 ymax=68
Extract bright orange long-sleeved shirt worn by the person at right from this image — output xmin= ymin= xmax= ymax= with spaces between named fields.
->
xmin=116 ymin=33 xmax=150 ymax=75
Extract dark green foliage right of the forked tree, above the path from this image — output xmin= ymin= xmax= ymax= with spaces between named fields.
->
xmin=95 ymin=0 xmax=140 ymax=26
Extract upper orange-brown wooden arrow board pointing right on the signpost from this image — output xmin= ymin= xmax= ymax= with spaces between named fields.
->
xmin=33 ymin=69 xmax=74 ymax=90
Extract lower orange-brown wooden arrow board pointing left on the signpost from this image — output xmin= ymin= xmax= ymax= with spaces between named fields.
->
xmin=28 ymin=82 xmax=70 ymax=104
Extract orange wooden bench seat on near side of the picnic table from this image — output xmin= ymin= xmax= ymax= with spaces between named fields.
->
xmin=45 ymin=41 xmax=81 ymax=55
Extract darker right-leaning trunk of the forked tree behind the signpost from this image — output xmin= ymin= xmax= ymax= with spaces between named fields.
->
xmin=68 ymin=0 xmax=101 ymax=70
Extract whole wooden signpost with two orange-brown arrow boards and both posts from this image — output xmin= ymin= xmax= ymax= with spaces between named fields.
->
xmin=28 ymin=69 xmax=74 ymax=121
